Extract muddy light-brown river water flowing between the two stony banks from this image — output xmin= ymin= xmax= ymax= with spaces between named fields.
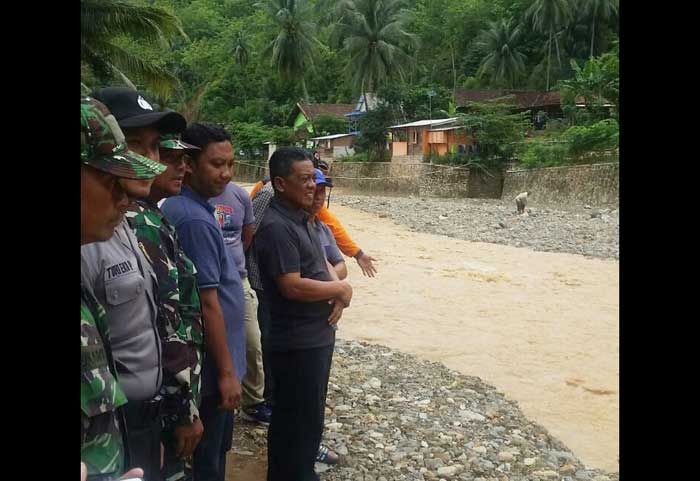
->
xmin=231 ymin=186 xmax=619 ymax=474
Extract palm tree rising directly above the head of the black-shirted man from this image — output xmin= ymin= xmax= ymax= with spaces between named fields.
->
xmin=258 ymin=0 xmax=319 ymax=101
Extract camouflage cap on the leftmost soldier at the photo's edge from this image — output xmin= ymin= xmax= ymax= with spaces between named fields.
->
xmin=80 ymin=97 xmax=167 ymax=179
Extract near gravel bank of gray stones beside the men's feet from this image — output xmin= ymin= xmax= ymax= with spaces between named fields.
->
xmin=234 ymin=340 xmax=619 ymax=481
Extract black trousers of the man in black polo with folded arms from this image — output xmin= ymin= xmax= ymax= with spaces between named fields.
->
xmin=267 ymin=345 xmax=333 ymax=481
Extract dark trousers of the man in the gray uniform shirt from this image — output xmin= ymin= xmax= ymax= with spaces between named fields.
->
xmin=123 ymin=401 xmax=163 ymax=481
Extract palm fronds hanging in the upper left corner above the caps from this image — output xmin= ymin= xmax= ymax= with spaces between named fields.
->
xmin=80 ymin=0 xmax=187 ymax=96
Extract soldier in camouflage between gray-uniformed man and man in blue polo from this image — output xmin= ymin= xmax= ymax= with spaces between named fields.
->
xmin=126 ymin=134 xmax=203 ymax=481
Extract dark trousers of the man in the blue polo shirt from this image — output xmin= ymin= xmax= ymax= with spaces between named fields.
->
xmin=192 ymin=394 xmax=233 ymax=481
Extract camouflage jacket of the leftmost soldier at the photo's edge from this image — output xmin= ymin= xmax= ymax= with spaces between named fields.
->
xmin=80 ymin=286 xmax=126 ymax=479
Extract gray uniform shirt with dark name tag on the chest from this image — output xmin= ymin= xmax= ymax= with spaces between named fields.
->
xmin=80 ymin=219 xmax=163 ymax=401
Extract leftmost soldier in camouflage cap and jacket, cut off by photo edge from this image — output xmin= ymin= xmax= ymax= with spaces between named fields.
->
xmin=80 ymin=97 xmax=164 ymax=480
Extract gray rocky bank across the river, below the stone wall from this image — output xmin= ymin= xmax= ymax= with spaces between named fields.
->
xmin=338 ymin=195 xmax=620 ymax=259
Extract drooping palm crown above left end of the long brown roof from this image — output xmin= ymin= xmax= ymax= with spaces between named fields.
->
xmin=479 ymin=19 xmax=526 ymax=88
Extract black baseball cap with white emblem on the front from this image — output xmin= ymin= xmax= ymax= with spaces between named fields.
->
xmin=92 ymin=87 xmax=187 ymax=133
